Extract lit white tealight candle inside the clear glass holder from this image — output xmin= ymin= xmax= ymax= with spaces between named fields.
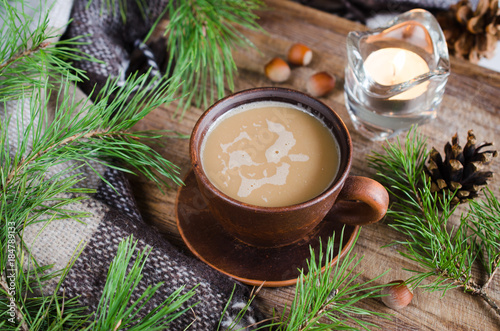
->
xmin=364 ymin=47 xmax=429 ymax=100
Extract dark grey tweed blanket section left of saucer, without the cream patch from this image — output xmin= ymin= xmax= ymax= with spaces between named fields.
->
xmin=61 ymin=169 xmax=257 ymax=331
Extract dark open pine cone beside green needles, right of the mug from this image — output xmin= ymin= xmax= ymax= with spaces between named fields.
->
xmin=426 ymin=130 xmax=498 ymax=204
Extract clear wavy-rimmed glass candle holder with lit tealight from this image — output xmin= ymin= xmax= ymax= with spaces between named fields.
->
xmin=344 ymin=9 xmax=450 ymax=140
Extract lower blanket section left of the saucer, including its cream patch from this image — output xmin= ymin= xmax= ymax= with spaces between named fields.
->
xmin=23 ymin=169 xmax=261 ymax=331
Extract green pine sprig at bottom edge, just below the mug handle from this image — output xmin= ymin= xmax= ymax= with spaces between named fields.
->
xmin=277 ymin=231 xmax=389 ymax=331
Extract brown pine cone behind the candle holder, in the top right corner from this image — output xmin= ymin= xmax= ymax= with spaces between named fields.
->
xmin=437 ymin=0 xmax=500 ymax=63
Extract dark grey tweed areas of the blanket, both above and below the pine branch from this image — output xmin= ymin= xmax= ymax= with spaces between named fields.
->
xmin=58 ymin=0 xmax=262 ymax=330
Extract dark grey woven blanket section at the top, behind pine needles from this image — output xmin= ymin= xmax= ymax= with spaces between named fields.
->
xmin=63 ymin=0 xmax=169 ymax=98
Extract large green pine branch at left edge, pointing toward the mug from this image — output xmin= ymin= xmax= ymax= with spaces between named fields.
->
xmin=0 ymin=70 xmax=185 ymax=244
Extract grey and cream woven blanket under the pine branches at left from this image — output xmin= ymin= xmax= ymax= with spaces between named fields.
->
xmin=0 ymin=0 xmax=258 ymax=331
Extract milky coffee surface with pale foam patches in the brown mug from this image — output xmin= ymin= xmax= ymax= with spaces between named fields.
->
xmin=201 ymin=101 xmax=339 ymax=207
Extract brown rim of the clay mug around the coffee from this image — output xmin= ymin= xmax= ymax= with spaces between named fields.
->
xmin=189 ymin=87 xmax=352 ymax=213
